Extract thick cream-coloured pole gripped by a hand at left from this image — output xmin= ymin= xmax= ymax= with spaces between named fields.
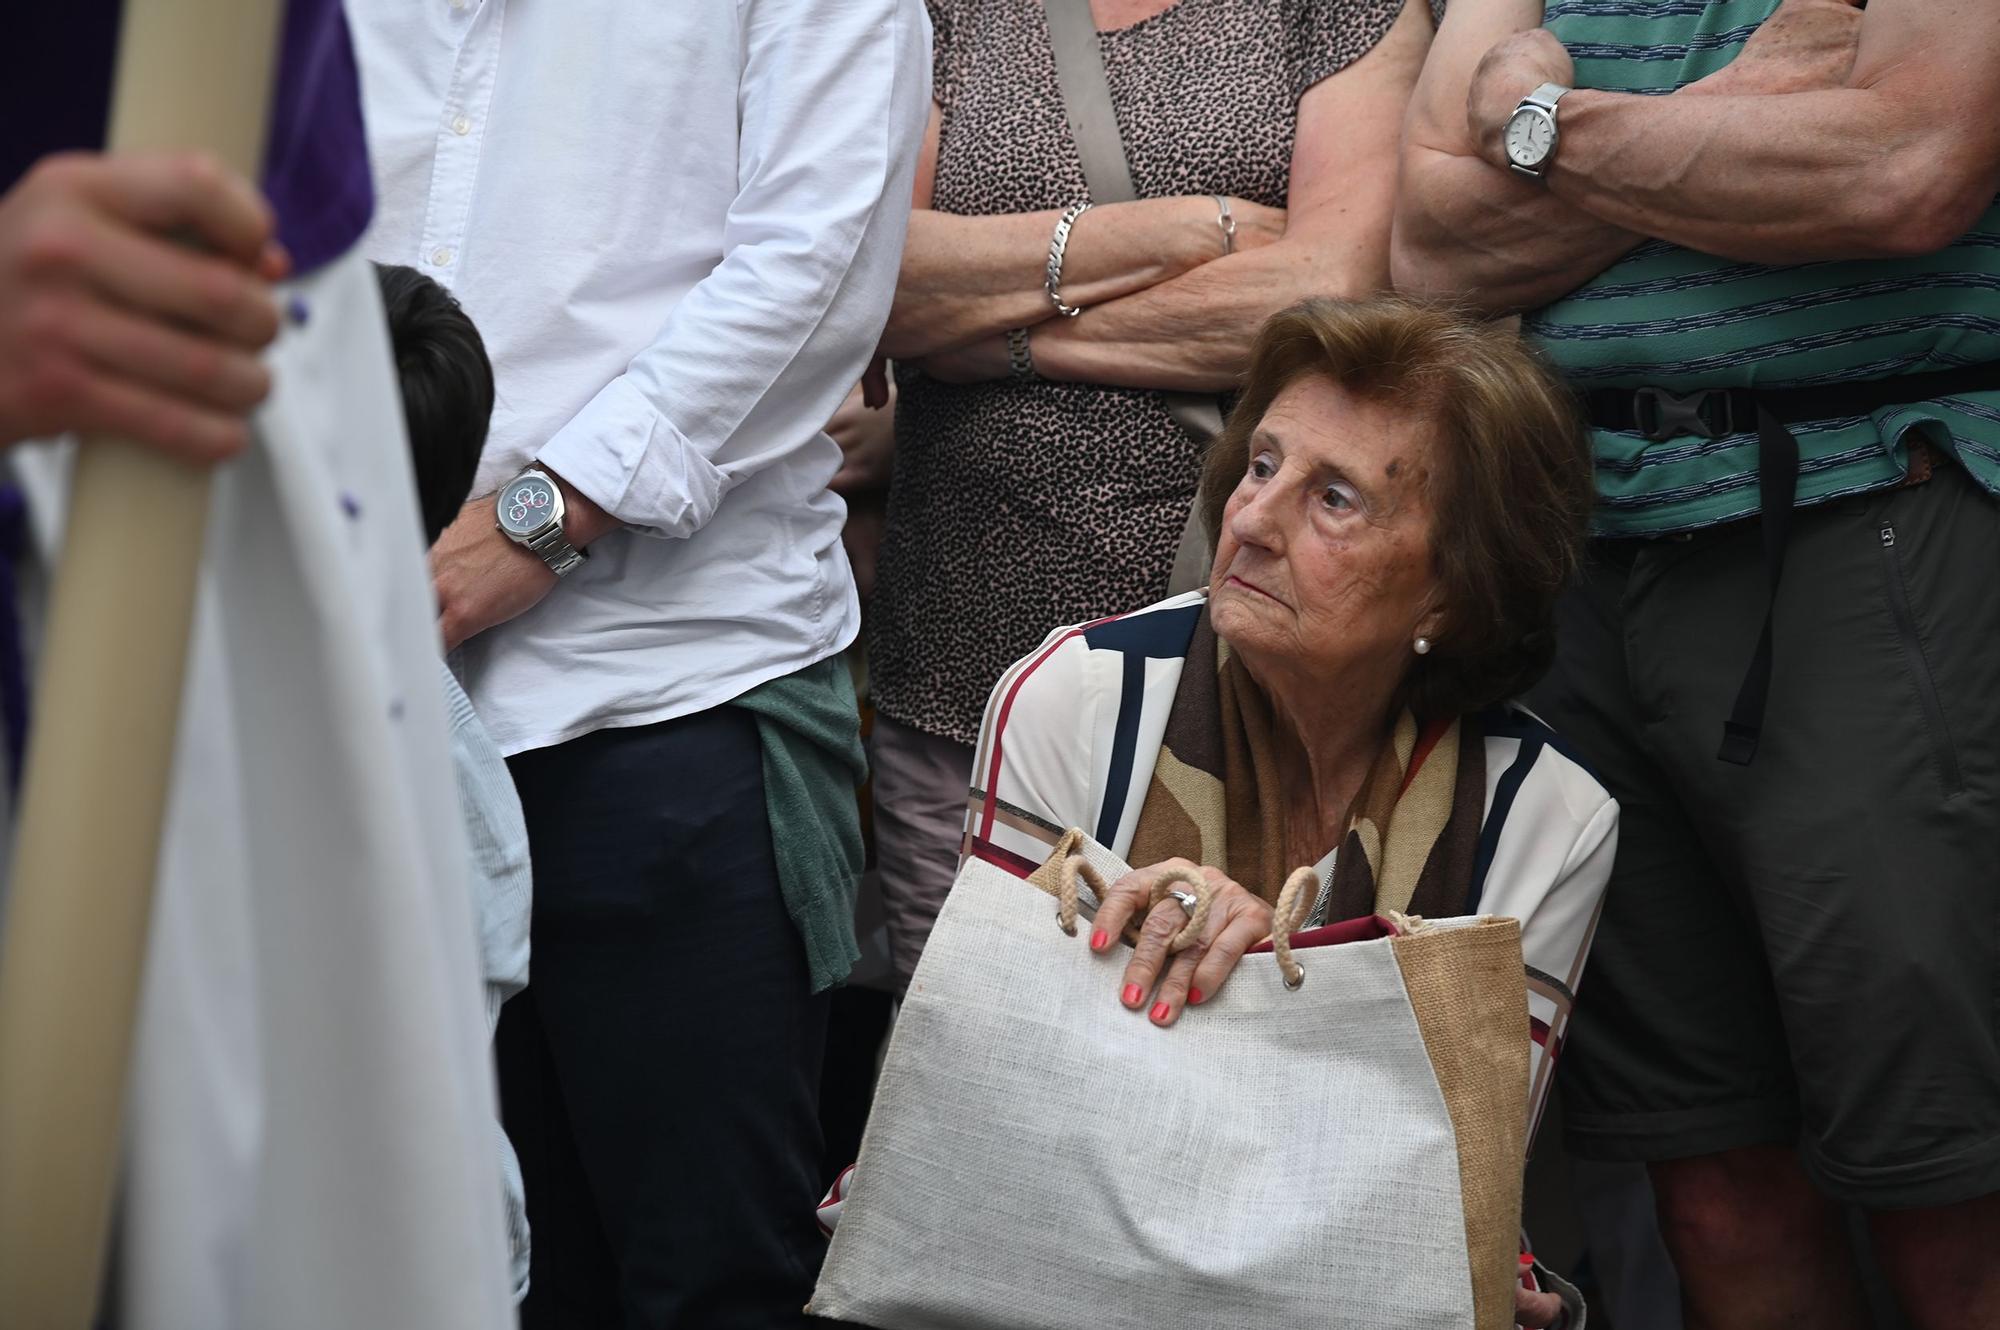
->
xmin=0 ymin=0 xmax=284 ymax=1330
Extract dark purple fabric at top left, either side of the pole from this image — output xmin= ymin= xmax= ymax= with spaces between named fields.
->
xmin=0 ymin=0 xmax=374 ymax=272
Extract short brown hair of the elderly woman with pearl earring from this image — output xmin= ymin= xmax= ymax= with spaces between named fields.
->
xmin=1196 ymin=296 xmax=1594 ymax=716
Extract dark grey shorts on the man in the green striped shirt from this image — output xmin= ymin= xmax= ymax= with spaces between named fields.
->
xmin=1530 ymin=464 xmax=2000 ymax=1208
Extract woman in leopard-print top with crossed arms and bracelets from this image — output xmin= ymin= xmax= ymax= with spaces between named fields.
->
xmin=868 ymin=0 xmax=1432 ymax=984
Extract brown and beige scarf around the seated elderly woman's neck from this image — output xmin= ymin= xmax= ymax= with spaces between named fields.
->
xmin=1130 ymin=612 xmax=1486 ymax=920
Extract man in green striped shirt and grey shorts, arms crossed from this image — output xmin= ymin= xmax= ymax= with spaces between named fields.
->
xmin=1394 ymin=0 xmax=2000 ymax=1330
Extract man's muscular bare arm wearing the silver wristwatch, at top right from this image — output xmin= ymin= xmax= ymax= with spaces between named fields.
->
xmin=1504 ymin=0 xmax=2000 ymax=264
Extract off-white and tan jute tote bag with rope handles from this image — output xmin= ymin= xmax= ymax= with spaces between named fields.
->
xmin=810 ymin=832 xmax=1528 ymax=1330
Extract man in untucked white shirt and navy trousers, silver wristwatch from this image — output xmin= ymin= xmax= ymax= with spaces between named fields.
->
xmin=348 ymin=0 xmax=930 ymax=1330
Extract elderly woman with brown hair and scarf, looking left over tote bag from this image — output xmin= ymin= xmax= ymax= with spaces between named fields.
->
xmin=966 ymin=300 xmax=1618 ymax=1326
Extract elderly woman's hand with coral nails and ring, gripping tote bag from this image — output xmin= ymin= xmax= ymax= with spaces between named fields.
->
xmin=1090 ymin=858 xmax=1272 ymax=1026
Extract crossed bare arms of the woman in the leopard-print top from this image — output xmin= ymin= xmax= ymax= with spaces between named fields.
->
xmin=884 ymin=4 xmax=1430 ymax=392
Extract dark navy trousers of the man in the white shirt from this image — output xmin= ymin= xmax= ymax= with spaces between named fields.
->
xmin=498 ymin=706 xmax=828 ymax=1330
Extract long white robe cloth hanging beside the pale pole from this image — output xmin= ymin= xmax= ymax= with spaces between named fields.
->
xmin=7 ymin=256 xmax=514 ymax=1330
